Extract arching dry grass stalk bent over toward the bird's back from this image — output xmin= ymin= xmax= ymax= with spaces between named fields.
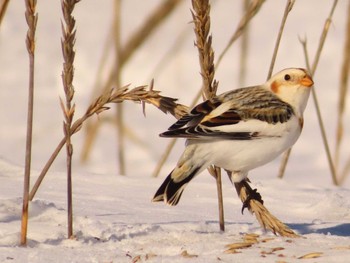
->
xmin=29 ymin=86 xmax=188 ymax=200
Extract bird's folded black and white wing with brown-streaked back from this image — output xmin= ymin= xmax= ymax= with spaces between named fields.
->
xmin=160 ymin=86 xmax=294 ymax=140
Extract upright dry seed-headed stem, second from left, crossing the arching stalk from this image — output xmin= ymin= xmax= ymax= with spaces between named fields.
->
xmin=61 ymin=0 xmax=80 ymax=238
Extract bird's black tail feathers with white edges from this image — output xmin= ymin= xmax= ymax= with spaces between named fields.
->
xmin=152 ymin=167 xmax=201 ymax=206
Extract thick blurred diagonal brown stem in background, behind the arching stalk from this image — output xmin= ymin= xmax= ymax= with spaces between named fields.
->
xmin=82 ymin=0 xmax=181 ymax=165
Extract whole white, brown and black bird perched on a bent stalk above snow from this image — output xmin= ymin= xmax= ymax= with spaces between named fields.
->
xmin=153 ymin=68 xmax=313 ymax=208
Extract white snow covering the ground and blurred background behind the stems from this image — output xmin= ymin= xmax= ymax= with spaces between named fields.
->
xmin=0 ymin=0 xmax=350 ymax=263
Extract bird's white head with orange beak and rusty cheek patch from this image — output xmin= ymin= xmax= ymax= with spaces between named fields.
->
xmin=266 ymin=68 xmax=314 ymax=115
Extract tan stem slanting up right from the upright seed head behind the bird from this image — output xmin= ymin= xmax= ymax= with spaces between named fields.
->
xmin=216 ymin=0 xmax=265 ymax=68
